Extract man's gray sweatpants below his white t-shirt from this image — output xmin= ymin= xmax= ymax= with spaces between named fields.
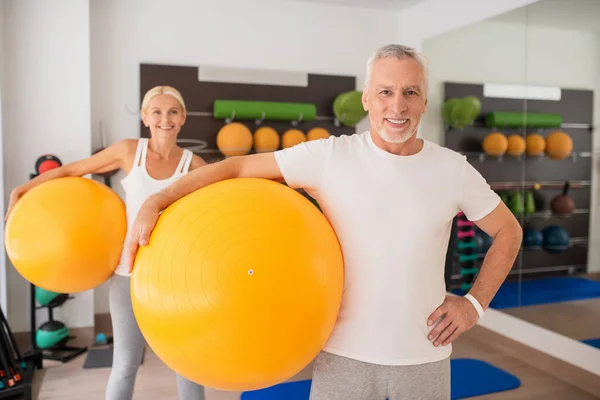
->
xmin=310 ymin=352 xmax=450 ymax=400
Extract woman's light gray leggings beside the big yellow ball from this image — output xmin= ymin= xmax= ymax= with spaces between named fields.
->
xmin=106 ymin=274 xmax=204 ymax=400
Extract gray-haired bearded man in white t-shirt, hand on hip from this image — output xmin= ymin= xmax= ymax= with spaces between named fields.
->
xmin=125 ymin=45 xmax=522 ymax=400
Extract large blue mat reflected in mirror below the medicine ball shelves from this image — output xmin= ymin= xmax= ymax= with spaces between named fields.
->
xmin=490 ymin=277 xmax=600 ymax=309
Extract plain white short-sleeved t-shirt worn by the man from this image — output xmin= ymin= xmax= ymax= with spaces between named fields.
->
xmin=274 ymin=131 xmax=500 ymax=365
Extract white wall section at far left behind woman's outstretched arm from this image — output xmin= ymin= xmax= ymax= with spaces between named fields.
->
xmin=3 ymin=0 xmax=94 ymax=332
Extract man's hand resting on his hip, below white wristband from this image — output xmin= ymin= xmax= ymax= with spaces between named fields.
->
xmin=427 ymin=295 xmax=479 ymax=347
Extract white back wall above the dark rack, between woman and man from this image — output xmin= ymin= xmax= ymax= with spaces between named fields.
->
xmin=90 ymin=0 xmax=398 ymax=313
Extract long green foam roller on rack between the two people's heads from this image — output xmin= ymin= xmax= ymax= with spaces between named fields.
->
xmin=213 ymin=100 xmax=317 ymax=121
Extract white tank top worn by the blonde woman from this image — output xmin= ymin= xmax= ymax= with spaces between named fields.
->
xmin=115 ymin=138 xmax=193 ymax=276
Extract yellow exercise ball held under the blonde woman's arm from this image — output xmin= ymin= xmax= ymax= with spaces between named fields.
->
xmin=4 ymin=177 xmax=127 ymax=293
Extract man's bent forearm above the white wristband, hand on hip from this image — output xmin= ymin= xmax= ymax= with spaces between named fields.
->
xmin=469 ymin=227 xmax=523 ymax=310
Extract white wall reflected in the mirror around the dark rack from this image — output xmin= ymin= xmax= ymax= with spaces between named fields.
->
xmin=421 ymin=21 xmax=600 ymax=271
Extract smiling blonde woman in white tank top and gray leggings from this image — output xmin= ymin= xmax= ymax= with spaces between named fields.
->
xmin=6 ymin=86 xmax=206 ymax=400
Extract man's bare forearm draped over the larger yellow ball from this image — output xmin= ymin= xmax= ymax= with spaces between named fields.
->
xmin=149 ymin=159 xmax=237 ymax=211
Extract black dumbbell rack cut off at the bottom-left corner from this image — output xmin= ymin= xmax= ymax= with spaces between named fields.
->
xmin=0 ymin=309 xmax=42 ymax=400
